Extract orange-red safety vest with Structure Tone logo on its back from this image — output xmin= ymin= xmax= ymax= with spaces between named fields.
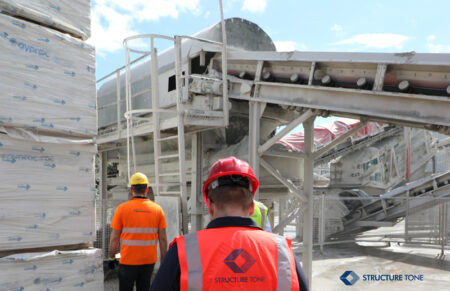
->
xmin=175 ymin=227 xmax=300 ymax=291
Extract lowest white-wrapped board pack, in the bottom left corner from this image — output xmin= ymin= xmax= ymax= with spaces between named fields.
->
xmin=0 ymin=249 xmax=103 ymax=291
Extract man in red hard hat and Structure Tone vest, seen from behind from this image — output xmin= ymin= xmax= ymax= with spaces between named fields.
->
xmin=150 ymin=157 xmax=308 ymax=291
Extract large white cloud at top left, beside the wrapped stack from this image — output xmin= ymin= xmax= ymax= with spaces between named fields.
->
xmin=88 ymin=0 xmax=200 ymax=54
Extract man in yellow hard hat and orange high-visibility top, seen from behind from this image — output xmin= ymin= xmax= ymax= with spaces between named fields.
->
xmin=108 ymin=173 xmax=167 ymax=291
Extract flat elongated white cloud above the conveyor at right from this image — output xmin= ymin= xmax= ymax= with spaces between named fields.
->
xmin=336 ymin=33 xmax=410 ymax=49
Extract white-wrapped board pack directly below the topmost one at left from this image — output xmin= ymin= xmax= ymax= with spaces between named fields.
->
xmin=0 ymin=14 xmax=97 ymax=136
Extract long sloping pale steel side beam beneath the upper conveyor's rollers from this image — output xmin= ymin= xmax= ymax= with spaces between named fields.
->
xmin=257 ymin=82 xmax=450 ymax=127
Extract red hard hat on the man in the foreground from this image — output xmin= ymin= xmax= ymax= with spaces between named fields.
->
xmin=203 ymin=157 xmax=259 ymax=205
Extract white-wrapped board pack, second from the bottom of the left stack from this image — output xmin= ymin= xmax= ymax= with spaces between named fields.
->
xmin=0 ymin=127 xmax=96 ymax=251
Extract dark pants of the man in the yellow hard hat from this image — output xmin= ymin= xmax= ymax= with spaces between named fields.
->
xmin=119 ymin=264 xmax=155 ymax=291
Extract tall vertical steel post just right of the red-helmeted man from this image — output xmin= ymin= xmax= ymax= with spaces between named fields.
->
xmin=303 ymin=117 xmax=315 ymax=289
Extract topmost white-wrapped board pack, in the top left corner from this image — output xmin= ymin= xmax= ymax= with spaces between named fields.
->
xmin=0 ymin=0 xmax=91 ymax=40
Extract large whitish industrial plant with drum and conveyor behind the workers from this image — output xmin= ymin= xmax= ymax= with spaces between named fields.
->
xmin=96 ymin=18 xmax=450 ymax=288
